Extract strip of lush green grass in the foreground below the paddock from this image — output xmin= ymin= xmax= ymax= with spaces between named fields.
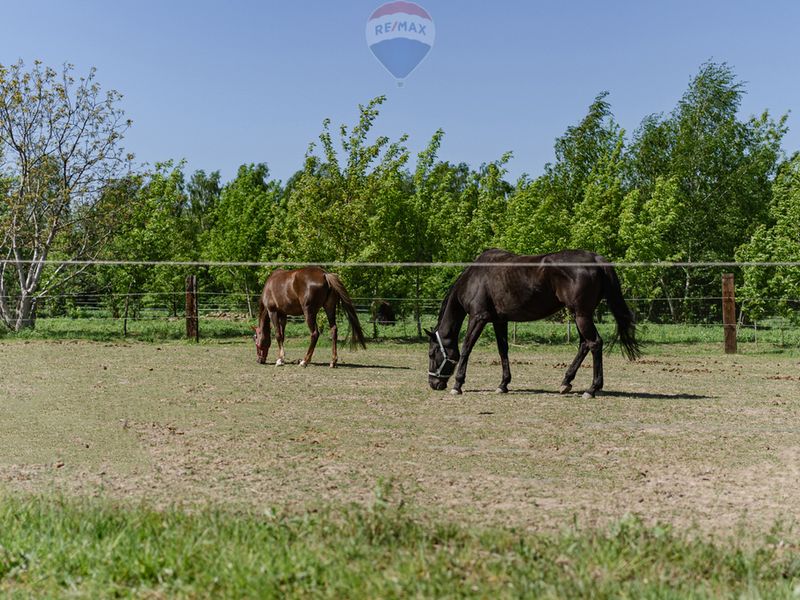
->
xmin=0 ymin=486 xmax=800 ymax=598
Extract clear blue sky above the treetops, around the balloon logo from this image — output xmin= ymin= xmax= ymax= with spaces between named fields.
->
xmin=0 ymin=0 xmax=800 ymax=179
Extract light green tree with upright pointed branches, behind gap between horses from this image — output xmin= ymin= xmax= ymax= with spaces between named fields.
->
xmin=285 ymin=96 xmax=415 ymax=296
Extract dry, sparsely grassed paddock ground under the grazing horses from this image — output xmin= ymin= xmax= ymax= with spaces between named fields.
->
xmin=0 ymin=340 xmax=800 ymax=534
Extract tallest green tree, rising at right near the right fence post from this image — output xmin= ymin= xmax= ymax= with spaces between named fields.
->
xmin=629 ymin=62 xmax=786 ymax=318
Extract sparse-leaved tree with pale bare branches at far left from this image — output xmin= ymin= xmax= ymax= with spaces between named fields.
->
xmin=0 ymin=61 xmax=132 ymax=331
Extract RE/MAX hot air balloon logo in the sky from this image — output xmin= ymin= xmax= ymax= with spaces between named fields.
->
xmin=367 ymin=2 xmax=436 ymax=85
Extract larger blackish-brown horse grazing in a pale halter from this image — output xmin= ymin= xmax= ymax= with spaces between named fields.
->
xmin=426 ymin=249 xmax=641 ymax=398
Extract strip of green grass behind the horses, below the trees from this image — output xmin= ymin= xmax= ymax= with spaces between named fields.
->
xmin=0 ymin=315 xmax=800 ymax=352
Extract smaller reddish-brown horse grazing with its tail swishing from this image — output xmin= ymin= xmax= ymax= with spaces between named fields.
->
xmin=253 ymin=267 xmax=367 ymax=368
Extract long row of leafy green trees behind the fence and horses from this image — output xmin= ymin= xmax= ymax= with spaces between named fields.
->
xmin=14 ymin=62 xmax=800 ymax=328
